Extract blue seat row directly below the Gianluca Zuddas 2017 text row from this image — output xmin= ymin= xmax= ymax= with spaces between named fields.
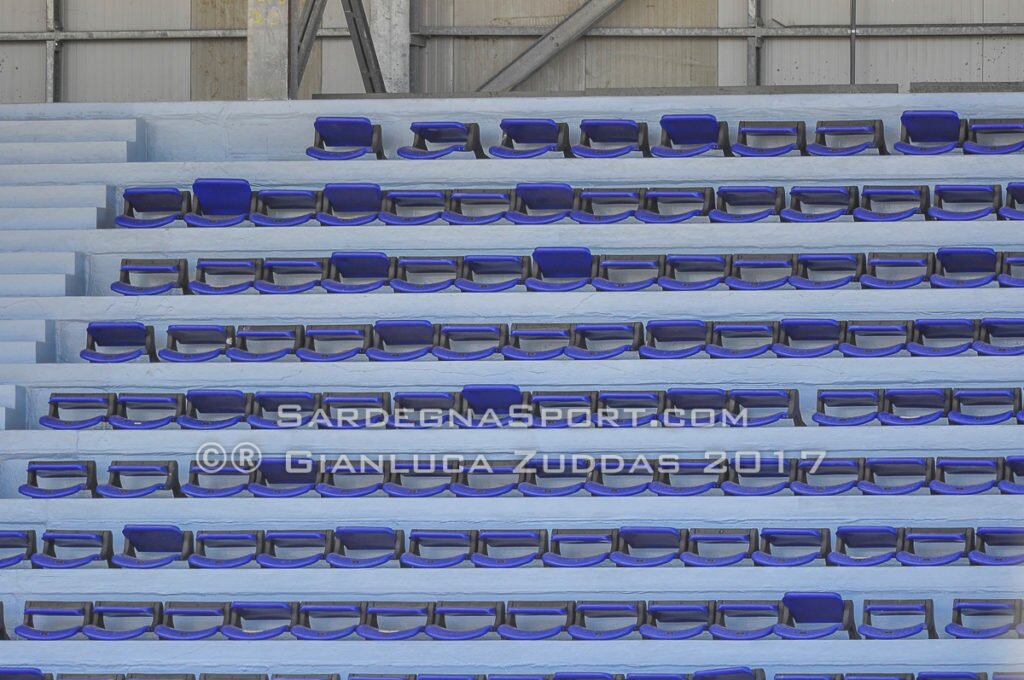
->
xmin=0 ymin=524 xmax=1024 ymax=569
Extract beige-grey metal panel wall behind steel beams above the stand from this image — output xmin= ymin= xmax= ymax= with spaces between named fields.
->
xmin=0 ymin=0 xmax=1024 ymax=103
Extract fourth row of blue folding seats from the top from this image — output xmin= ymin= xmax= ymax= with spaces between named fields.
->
xmin=80 ymin=318 xmax=1024 ymax=364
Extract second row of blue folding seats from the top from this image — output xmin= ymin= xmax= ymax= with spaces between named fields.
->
xmin=115 ymin=178 xmax=1024 ymax=228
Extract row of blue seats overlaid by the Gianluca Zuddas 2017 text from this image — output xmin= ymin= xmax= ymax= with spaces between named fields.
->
xmin=18 ymin=455 xmax=1024 ymax=497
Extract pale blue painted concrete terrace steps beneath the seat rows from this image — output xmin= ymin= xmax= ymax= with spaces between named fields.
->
xmin=0 ymin=93 xmax=1024 ymax=677
